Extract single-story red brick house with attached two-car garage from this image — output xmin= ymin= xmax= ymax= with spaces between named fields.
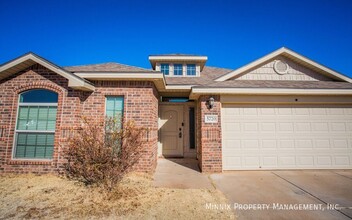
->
xmin=0 ymin=48 xmax=352 ymax=172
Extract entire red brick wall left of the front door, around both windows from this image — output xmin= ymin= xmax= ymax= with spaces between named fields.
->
xmin=0 ymin=65 xmax=158 ymax=173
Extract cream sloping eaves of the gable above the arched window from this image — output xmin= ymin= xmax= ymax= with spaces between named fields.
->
xmin=0 ymin=52 xmax=95 ymax=91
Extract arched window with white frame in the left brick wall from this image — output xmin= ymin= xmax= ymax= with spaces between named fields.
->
xmin=14 ymin=89 xmax=58 ymax=159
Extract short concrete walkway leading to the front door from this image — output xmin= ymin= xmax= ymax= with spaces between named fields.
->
xmin=154 ymin=158 xmax=214 ymax=189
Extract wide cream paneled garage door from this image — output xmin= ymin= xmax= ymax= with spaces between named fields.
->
xmin=221 ymin=104 xmax=352 ymax=170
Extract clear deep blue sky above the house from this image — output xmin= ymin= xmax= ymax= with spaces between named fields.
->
xmin=0 ymin=0 xmax=352 ymax=76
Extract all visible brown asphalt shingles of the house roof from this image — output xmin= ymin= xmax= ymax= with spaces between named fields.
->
xmin=64 ymin=62 xmax=352 ymax=89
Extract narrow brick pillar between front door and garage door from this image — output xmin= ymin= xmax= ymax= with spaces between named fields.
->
xmin=197 ymin=95 xmax=222 ymax=172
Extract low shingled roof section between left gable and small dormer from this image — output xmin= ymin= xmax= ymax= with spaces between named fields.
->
xmin=64 ymin=62 xmax=157 ymax=73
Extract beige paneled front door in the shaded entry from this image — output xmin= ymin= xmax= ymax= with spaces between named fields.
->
xmin=160 ymin=105 xmax=183 ymax=157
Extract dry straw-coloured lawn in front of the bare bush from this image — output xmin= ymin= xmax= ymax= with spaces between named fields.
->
xmin=0 ymin=173 xmax=235 ymax=219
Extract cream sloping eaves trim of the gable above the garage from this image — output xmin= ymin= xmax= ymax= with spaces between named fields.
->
xmin=215 ymin=47 xmax=352 ymax=83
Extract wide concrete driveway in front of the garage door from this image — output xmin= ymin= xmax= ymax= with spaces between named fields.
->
xmin=210 ymin=170 xmax=352 ymax=219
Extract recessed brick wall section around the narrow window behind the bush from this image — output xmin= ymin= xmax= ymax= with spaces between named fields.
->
xmin=82 ymin=81 xmax=158 ymax=172
